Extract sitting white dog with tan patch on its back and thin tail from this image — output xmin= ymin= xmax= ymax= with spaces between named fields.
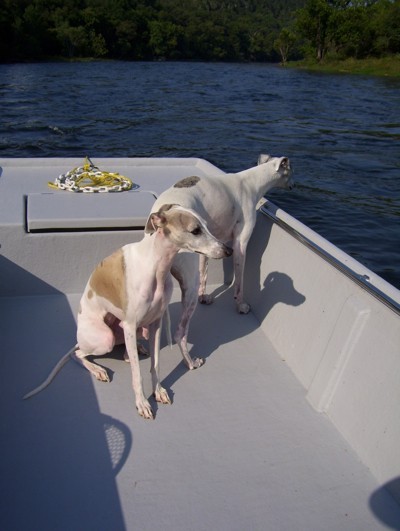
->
xmin=24 ymin=204 xmax=232 ymax=419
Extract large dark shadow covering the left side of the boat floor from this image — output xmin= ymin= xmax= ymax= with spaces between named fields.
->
xmin=0 ymin=286 xmax=133 ymax=530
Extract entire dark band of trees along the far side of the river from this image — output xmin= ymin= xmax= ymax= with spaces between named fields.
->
xmin=0 ymin=0 xmax=400 ymax=62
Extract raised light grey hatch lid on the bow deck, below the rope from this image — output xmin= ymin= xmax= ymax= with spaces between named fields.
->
xmin=26 ymin=191 xmax=155 ymax=232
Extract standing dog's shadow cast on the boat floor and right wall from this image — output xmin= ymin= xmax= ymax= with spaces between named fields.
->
xmin=163 ymin=214 xmax=306 ymax=391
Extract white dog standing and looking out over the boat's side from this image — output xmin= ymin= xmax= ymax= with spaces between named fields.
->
xmin=146 ymin=155 xmax=293 ymax=369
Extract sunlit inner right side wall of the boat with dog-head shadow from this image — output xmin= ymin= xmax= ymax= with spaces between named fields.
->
xmin=244 ymin=214 xmax=400 ymax=501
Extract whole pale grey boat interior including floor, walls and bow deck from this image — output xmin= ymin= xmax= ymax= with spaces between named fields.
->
xmin=0 ymin=159 xmax=400 ymax=531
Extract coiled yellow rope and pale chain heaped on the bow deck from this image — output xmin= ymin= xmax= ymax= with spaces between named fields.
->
xmin=48 ymin=157 xmax=134 ymax=192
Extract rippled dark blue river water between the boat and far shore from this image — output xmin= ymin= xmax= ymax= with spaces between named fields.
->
xmin=0 ymin=62 xmax=400 ymax=288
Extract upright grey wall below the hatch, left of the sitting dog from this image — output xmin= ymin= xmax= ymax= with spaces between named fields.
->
xmin=0 ymin=227 xmax=143 ymax=297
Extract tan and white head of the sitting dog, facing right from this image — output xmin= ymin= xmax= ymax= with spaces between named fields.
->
xmin=145 ymin=205 xmax=232 ymax=258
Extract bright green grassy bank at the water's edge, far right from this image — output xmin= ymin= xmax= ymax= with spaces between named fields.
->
xmin=286 ymin=55 xmax=400 ymax=77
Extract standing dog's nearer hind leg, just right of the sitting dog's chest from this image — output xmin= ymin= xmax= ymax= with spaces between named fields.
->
xmin=171 ymin=253 xmax=204 ymax=370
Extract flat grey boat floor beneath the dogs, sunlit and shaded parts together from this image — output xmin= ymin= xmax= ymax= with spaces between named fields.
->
xmin=0 ymin=293 xmax=400 ymax=531
